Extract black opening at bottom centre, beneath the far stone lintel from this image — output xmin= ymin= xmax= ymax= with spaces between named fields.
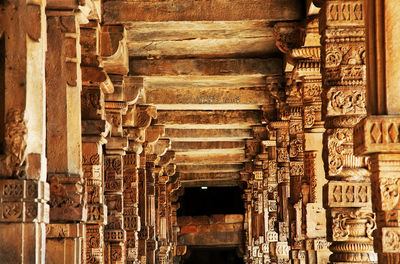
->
xmin=182 ymin=248 xmax=243 ymax=264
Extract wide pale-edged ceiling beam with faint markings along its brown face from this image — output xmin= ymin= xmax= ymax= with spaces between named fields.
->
xmin=141 ymin=75 xmax=271 ymax=110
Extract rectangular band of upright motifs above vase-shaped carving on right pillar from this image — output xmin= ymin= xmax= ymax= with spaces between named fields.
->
xmin=328 ymin=181 xmax=371 ymax=207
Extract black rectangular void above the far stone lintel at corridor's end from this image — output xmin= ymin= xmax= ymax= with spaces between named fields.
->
xmin=177 ymin=187 xmax=244 ymax=216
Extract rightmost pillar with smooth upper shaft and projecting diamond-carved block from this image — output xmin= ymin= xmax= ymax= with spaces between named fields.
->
xmin=354 ymin=0 xmax=400 ymax=264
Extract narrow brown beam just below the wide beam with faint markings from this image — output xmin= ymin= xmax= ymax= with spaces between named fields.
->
xmin=156 ymin=110 xmax=261 ymax=128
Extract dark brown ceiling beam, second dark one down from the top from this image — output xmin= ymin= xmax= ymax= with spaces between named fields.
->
xmin=129 ymin=58 xmax=282 ymax=76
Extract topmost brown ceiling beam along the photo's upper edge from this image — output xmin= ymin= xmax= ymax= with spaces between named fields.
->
xmin=103 ymin=0 xmax=303 ymax=24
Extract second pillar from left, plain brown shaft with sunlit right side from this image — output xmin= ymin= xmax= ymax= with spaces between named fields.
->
xmin=46 ymin=5 xmax=87 ymax=263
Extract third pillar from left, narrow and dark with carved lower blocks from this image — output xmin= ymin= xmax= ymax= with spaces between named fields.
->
xmin=80 ymin=10 xmax=114 ymax=264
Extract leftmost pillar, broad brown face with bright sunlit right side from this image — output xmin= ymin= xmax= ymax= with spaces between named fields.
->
xmin=0 ymin=1 xmax=49 ymax=263
